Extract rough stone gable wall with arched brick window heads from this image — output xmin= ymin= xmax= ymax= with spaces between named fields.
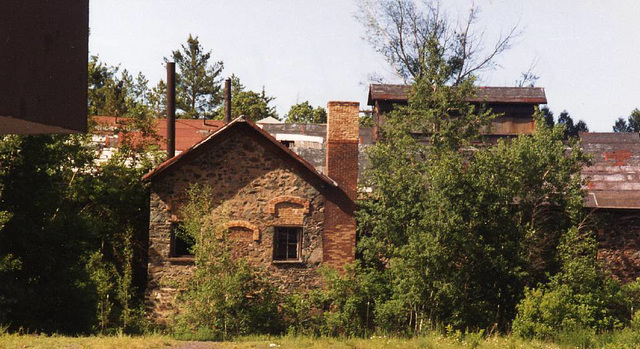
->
xmin=146 ymin=129 xmax=325 ymax=322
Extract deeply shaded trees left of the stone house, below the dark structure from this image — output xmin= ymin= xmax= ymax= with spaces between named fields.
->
xmin=0 ymin=135 xmax=156 ymax=333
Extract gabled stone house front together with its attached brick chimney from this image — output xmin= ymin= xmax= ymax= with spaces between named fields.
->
xmin=143 ymin=102 xmax=360 ymax=320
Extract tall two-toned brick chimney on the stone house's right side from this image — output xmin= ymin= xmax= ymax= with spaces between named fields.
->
xmin=322 ymin=102 xmax=360 ymax=269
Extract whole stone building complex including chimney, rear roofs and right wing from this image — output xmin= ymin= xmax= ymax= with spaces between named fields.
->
xmin=139 ymin=85 xmax=640 ymax=321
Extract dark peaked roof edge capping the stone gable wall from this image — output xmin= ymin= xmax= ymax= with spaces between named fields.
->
xmin=142 ymin=116 xmax=338 ymax=187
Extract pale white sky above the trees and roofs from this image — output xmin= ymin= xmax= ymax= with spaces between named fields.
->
xmin=89 ymin=0 xmax=640 ymax=132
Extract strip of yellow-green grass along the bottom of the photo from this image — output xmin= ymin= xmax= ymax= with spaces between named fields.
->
xmin=0 ymin=332 xmax=640 ymax=349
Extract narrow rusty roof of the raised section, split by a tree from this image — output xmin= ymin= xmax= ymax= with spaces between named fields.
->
xmin=367 ymin=84 xmax=547 ymax=105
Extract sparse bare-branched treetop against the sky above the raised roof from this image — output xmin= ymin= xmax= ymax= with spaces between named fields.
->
xmin=358 ymin=0 xmax=518 ymax=84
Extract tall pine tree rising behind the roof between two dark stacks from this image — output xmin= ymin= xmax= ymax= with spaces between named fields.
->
xmin=164 ymin=34 xmax=224 ymax=119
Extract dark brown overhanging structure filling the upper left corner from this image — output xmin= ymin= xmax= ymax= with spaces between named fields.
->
xmin=0 ymin=0 xmax=89 ymax=134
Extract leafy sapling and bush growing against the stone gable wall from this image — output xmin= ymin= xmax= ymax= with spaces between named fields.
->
xmin=173 ymin=186 xmax=282 ymax=340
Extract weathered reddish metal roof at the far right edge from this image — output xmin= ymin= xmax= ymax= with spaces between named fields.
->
xmin=580 ymin=133 xmax=640 ymax=209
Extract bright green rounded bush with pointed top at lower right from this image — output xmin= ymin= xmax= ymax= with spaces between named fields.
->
xmin=513 ymin=228 xmax=635 ymax=338
